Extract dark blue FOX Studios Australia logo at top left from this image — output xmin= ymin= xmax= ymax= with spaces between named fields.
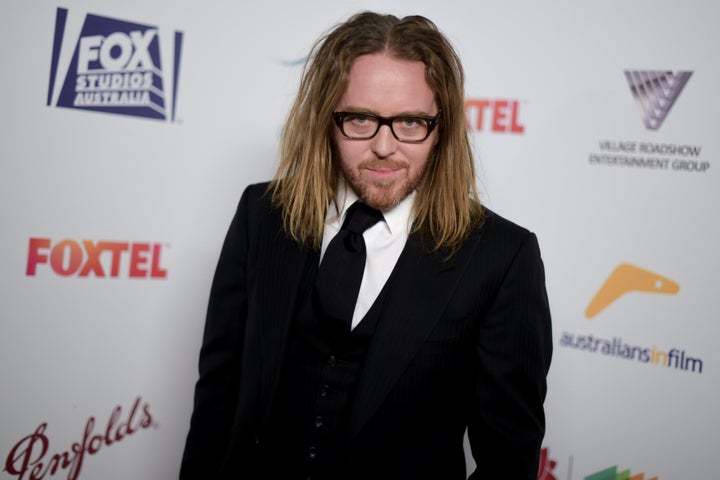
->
xmin=47 ymin=8 xmax=183 ymax=121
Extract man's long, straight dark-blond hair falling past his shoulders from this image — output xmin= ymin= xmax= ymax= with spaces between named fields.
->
xmin=270 ymin=12 xmax=483 ymax=255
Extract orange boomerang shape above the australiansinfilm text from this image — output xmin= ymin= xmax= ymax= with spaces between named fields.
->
xmin=585 ymin=263 xmax=680 ymax=318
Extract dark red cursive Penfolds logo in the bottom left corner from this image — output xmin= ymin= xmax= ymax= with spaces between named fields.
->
xmin=5 ymin=397 xmax=156 ymax=480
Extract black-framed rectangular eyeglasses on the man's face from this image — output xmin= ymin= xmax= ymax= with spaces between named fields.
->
xmin=333 ymin=111 xmax=442 ymax=143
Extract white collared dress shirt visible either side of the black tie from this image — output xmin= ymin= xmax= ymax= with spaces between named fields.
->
xmin=320 ymin=181 xmax=415 ymax=328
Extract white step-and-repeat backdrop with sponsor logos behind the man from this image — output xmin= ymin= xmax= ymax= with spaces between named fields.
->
xmin=0 ymin=0 xmax=720 ymax=480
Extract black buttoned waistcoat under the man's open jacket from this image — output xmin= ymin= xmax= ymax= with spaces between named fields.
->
xmin=262 ymin=258 xmax=386 ymax=480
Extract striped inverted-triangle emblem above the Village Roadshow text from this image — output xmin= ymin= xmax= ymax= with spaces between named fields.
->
xmin=625 ymin=70 xmax=692 ymax=130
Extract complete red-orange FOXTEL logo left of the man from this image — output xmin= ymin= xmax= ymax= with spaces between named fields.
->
xmin=25 ymin=238 xmax=167 ymax=279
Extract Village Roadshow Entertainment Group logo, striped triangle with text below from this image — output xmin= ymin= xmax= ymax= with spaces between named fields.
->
xmin=589 ymin=70 xmax=710 ymax=174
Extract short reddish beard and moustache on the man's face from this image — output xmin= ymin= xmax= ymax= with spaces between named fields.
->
xmin=339 ymin=160 xmax=428 ymax=211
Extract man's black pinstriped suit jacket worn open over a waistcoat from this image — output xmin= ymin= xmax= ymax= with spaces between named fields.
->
xmin=180 ymin=184 xmax=552 ymax=480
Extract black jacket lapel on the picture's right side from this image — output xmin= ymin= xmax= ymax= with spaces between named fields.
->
xmin=348 ymin=235 xmax=477 ymax=438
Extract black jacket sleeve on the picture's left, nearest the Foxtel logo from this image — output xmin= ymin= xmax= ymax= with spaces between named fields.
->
xmin=180 ymin=190 xmax=249 ymax=480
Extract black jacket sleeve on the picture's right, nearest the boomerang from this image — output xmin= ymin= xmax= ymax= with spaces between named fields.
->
xmin=468 ymin=231 xmax=552 ymax=480
